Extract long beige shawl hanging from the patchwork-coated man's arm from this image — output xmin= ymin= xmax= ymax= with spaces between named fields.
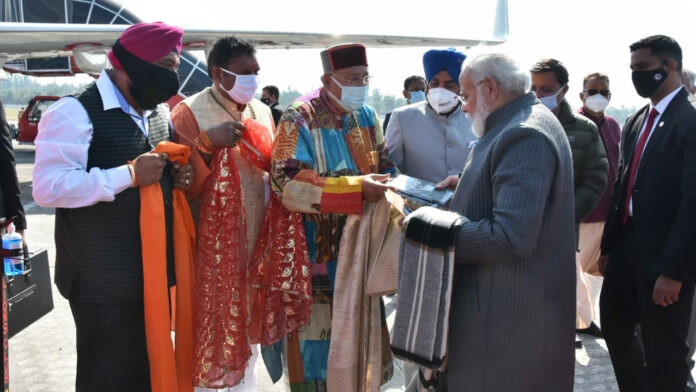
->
xmin=326 ymin=199 xmax=398 ymax=392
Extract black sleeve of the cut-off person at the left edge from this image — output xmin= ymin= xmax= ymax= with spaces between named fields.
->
xmin=0 ymin=101 xmax=27 ymax=230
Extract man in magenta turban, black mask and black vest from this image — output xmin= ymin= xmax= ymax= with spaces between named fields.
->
xmin=33 ymin=22 xmax=192 ymax=392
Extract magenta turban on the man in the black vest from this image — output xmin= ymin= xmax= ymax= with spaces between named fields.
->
xmin=109 ymin=22 xmax=184 ymax=69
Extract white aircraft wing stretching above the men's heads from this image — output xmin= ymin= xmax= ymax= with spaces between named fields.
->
xmin=0 ymin=23 xmax=506 ymax=61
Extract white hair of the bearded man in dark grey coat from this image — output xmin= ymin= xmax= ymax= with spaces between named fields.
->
xmin=460 ymin=53 xmax=531 ymax=96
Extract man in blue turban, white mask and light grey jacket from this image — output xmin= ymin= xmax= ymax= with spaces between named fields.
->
xmin=386 ymin=48 xmax=476 ymax=188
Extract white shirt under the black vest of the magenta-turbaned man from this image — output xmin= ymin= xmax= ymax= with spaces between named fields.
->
xmin=32 ymin=71 xmax=170 ymax=208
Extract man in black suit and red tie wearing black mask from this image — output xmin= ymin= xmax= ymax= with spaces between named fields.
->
xmin=600 ymin=35 xmax=696 ymax=392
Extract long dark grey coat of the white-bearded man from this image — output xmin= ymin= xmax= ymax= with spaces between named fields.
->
xmin=446 ymin=93 xmax=575 ymax=392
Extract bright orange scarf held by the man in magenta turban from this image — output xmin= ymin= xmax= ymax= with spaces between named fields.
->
xmin=140 ymin=142 xmax=196 ymax=392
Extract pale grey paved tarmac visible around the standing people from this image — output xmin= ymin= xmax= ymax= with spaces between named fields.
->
xmin=9 ymin=140 xmax=632 ymax=392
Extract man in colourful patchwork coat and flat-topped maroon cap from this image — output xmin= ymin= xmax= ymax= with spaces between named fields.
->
xmin=270 ymin=43 xmax=396 ymax=392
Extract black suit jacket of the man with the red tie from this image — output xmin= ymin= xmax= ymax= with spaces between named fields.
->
xmin=602 ymin=88 xmax=696 ymax=280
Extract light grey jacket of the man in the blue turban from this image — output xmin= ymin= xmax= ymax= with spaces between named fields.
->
xmin=386 ymin=101 xmax=476 ymax=182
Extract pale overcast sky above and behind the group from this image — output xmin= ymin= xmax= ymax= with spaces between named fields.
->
xmin=116 ymin=0 xmax=696 ymax=107
